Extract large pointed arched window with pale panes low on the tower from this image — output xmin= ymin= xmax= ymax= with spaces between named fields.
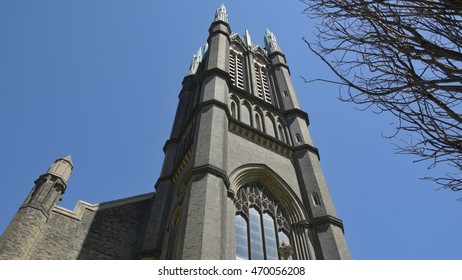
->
xmin=235 ymin=182 xmax=290 ymax=260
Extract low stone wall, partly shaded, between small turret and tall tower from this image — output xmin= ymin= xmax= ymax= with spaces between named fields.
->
xmin=29 ymin=194 xmax=153 ymax=260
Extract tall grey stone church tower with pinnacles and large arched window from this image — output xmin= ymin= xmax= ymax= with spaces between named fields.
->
xmin=140 ymin=5 xmax=350 ymax=260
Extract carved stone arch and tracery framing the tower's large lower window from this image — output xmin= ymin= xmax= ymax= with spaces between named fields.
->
xmin=229 ymin=164 xmax=314 ymax=260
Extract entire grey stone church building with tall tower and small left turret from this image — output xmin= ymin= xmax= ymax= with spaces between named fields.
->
xmin=0 ymin=5 xmax=350 ymax=260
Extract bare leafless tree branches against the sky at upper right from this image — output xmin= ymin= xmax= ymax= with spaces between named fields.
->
xmin=301 ymin=0 xmax=462 ymax=191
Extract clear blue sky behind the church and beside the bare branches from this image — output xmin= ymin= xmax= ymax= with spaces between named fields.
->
xmin=0 ymin=0 xmax=462 ymax=259
